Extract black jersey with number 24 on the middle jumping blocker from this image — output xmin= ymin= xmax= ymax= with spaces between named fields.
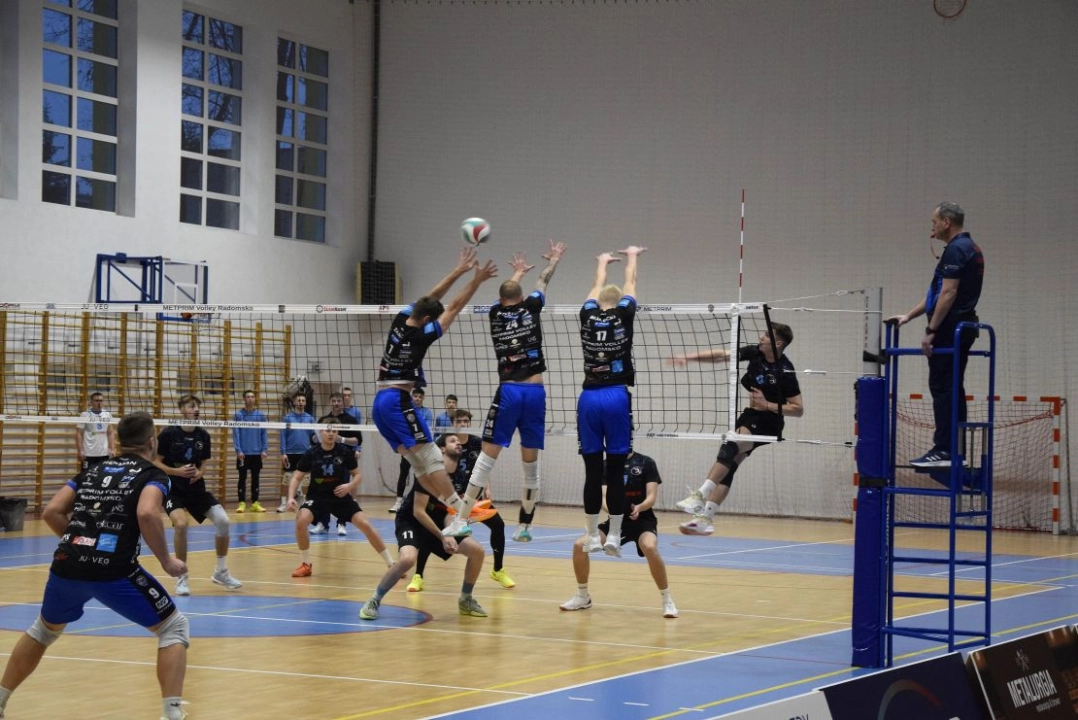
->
xmin=489 ymin=290 xmax=547 ymax=382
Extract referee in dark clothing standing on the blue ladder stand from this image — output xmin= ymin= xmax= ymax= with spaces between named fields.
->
xmin=886 ymin=203 xmax=984 ymax=468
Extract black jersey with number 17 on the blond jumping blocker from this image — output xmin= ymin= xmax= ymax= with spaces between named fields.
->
xmin=580 ymin=295 xmax=636 ymax=389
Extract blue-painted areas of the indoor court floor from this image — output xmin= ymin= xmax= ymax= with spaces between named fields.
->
xmin=0 ymin=517 xmax=1078 ymax=720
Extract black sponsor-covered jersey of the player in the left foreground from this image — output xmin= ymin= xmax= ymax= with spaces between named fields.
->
xmin=52 ymin=455 xmax=169 ymax=581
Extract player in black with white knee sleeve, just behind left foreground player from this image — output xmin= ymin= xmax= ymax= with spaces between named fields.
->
xmin=154 ymin=394 xmax=244 ymax=595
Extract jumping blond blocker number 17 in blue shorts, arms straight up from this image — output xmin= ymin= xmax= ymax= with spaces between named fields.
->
xmin=577 ymin=245 xmax=647 ymax=557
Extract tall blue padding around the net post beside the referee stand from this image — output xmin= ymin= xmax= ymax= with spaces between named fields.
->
xmin=851 ymin=377 xmax=889 ymax=667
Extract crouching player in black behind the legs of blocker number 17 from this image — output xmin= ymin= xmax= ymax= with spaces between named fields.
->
xmin=561 ymin=453 xmax=677 ymax=618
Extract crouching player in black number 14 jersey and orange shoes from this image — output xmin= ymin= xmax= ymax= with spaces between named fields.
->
xmin=288 ymin=428 xmax=393 ymax=578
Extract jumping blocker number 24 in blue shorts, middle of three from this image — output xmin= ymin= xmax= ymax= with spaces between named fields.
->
xmin=466 ymin=240 xmax=565 ymax=542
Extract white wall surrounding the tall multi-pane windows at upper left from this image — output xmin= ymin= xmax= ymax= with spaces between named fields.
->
xmin=0 ymin=0 xmax=370 ymax=303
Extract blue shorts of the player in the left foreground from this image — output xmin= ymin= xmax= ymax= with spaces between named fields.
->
xmin=41 ymin=567 xmax=176 ymax=627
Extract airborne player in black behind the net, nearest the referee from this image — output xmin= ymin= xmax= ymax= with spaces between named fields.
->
xmin=671 ymin=322 xmax=805 ymax=535
